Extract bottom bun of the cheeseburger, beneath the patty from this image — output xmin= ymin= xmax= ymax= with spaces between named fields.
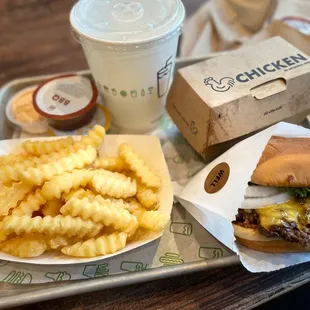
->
xmin=233 ymin=224 xmax=310 ymax=253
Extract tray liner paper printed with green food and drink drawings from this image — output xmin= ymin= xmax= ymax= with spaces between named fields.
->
xmin=0 ymin=118 xmax=232 ymax=284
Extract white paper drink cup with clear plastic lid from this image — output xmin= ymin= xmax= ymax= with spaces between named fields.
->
xmin=70 ymin=0 xmax=185 ymax=133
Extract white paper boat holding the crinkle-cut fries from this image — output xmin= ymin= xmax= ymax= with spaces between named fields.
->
xmin=0 ymin=135 xmax=173 ymax=265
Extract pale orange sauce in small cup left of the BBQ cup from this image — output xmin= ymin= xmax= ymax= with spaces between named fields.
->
xmin=12 ymin=88 xmax=43 ymax=123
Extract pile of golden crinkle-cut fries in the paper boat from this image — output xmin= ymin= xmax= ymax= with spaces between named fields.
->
xmin=0 ymin=125 xmax=169 ymax=258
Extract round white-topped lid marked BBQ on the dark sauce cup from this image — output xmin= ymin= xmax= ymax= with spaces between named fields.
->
xmin=33 ymin=74 xmax=98 ymax=120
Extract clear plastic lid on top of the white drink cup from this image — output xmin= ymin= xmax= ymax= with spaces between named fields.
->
xmin=70 ymin=0 xmax=185 ymax=44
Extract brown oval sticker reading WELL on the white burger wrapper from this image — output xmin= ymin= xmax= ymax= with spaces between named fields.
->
xmin=205 ymin=163 xmax=230 ymax=194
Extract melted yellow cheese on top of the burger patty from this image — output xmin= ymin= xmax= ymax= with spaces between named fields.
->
xmin=255 ymin=200 xmax=310 ymax=230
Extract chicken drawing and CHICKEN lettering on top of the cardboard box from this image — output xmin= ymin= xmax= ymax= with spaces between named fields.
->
xmin=204 ymin=53 xmax=310 ymax=92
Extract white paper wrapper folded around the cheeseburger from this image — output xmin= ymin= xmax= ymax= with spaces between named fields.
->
xmin=178 ymin=123 xmax=310 ymax=272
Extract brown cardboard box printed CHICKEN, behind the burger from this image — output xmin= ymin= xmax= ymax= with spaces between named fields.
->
xmin=167 ymin=37 xmax=310 ymax=158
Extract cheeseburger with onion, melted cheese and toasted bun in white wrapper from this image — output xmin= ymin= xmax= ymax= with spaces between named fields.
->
xmin=233 ymin=137 xmax=310 ymax=253
